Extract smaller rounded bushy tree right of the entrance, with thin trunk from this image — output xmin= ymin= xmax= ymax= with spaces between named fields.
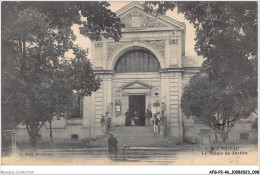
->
xmin=181 ymin=73 xmax=254 ymax=142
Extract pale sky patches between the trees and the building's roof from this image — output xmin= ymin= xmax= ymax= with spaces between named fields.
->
xmin=68 ymin=1 xmax=197 ymax=59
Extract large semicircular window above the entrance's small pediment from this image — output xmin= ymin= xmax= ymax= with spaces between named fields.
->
xmin=115 ymin=49 xmax=160 ymax=73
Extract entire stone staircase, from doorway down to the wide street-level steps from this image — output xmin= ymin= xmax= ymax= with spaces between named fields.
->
xmin=17 ymin=126 xmax=201 ymax=163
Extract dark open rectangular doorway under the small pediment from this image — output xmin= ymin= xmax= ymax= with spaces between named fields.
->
xmin=129 ymin=95 xmax=145 ymax=126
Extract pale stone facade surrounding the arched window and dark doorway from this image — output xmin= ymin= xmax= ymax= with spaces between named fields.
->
xmin=83 ymin=2 xmax=200 ymax=139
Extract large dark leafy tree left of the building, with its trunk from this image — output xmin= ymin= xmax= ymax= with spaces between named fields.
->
xmin=1 ymin=2 xmax=123 ymax=146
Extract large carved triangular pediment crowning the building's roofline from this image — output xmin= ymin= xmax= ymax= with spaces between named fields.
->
xmin=116 ymin=2 xmax=185 ymax=31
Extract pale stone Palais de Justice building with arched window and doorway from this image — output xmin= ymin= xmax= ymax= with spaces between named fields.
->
xmin=15 ymin=2 xmax=201 ymax=144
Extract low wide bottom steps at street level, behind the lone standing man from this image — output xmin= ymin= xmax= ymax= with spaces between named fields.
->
xmin=19 ymin=147 xmax=199 ymax=162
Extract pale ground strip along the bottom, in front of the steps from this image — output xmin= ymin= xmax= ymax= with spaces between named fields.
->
xmin=2 ymin=147 xmax=258 ymax=165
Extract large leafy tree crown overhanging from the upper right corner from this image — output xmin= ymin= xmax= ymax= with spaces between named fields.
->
xmin=146 ymin=1 xmax=258 ymax=104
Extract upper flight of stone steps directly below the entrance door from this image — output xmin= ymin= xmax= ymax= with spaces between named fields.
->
xmin=89 ymin=126 xmax=164 ymax=147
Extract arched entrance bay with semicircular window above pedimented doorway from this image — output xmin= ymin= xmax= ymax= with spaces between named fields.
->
xmin=114 ymin=48 xmax=161 ymax=126
